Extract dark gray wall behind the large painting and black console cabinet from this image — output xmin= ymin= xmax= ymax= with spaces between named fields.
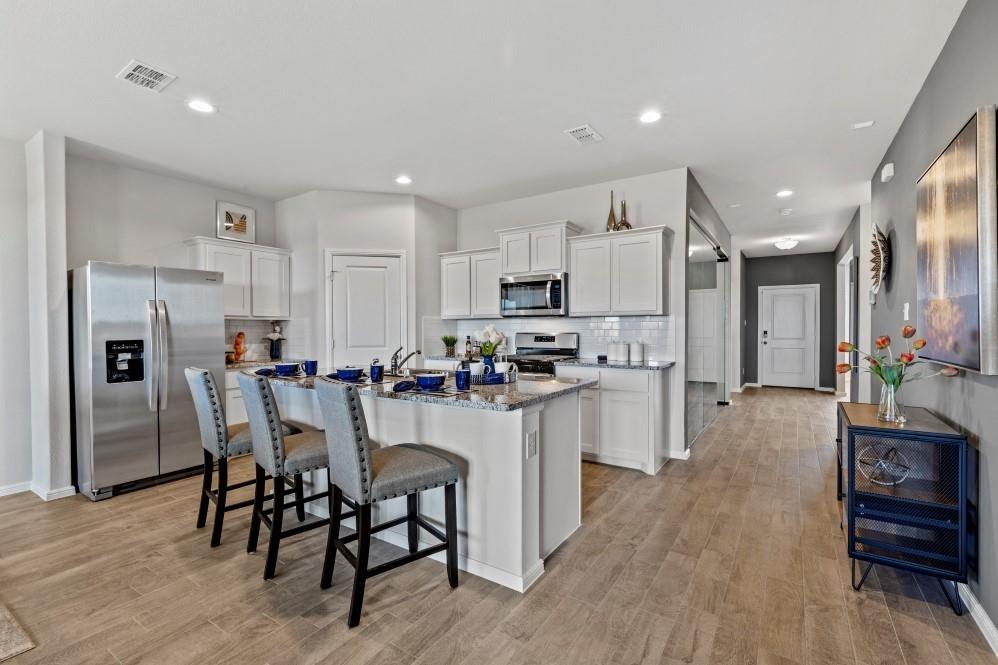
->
xmin=871 ymin=0 xmax=998 ymax=621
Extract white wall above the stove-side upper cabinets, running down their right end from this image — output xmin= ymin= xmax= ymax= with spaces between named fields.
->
xmin=457 ymin=168 xmax=696 ymax=455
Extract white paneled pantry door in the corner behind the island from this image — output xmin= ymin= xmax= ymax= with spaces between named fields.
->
xmin=330 ymin=256 xmax=405 ymax=367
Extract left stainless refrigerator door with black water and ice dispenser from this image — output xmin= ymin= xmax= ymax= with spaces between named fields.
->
xmin=87 ymin=262 xmax=159 ymax=491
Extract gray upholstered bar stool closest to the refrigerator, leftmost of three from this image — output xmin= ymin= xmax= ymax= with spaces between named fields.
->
xmin=184 ymin=367 xmax=314 ymax=547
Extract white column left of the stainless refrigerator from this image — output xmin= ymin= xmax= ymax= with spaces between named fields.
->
xmin=25 ymin=132 xmax=75 ymax=501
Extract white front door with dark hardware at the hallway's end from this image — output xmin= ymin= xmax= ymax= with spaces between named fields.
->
xmin=759 ymin=285 xmax=818 ymax=388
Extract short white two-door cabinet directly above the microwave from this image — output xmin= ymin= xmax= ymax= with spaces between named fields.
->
xmin=497 ymin=220 xmax=579 ymax=275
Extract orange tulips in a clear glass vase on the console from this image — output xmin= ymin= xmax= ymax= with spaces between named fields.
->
xmin=835 ymin=326 xmax=960 ymax=424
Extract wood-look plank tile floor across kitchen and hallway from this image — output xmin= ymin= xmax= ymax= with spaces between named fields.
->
xmin=0 ymin=389 xmax=996 ymax=665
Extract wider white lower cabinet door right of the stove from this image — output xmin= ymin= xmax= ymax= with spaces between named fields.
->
xmin=599 ymin=389 xmax=650 ymax=463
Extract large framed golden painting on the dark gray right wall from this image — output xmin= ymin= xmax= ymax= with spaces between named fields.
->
xmin=915 ymin=106 xmax=998 ymax=374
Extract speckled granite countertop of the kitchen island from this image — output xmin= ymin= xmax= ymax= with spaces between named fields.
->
xmin=247 ymin=369 xmax=596 ymax=411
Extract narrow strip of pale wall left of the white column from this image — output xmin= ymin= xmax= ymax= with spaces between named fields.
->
xmin=0 ymin=139 xmax=31 ymax=496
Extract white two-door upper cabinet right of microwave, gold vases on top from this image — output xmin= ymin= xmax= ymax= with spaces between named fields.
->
xmin=568 ymin=226 xmax=669 ymax=316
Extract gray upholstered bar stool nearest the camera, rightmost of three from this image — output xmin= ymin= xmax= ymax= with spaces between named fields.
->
xmin=315 ymin=379 xmax=458 ymax=628
